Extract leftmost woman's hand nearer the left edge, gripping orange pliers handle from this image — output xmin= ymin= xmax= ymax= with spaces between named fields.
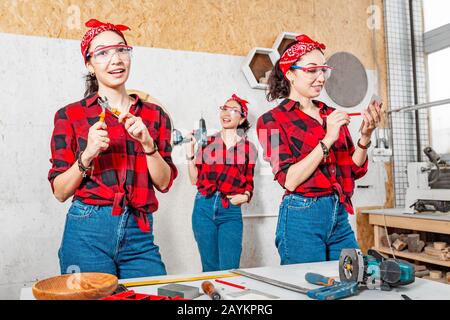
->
xmin=82 ymin=121 xmax=110 ymax=167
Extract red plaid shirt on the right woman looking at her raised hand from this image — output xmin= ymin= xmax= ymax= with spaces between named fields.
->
xmin=257 ymin=99 xmax=368 ymax=214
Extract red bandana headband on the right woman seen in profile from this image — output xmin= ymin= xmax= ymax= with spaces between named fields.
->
xmin=280 ymin=34 xmax=326 ymax=75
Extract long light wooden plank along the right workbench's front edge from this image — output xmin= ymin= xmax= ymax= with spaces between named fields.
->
xmin=369 ymin=214 xmax=450 ymax=234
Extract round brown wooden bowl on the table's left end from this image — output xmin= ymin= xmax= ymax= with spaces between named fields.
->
xmin=33 ymin=272 xmax=118 ymax=300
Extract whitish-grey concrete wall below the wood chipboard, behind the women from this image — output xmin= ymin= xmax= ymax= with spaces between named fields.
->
xmin=0 ymin=34 xmax=385 ymax=299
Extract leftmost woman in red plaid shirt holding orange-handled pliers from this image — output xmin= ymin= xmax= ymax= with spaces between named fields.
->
xmin=48 ymin=19 xmax=177 ymax=278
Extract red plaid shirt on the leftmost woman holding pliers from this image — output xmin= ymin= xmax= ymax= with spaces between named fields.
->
xmin=48 ymin=94 xmax=177 ymax=232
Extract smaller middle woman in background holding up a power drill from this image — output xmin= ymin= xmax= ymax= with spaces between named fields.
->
xmin=186 ymin=94 xmax=257 ymax=272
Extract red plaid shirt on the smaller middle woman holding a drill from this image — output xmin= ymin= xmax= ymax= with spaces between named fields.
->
xmin=195 ymin=132 xmax=257 ymax=208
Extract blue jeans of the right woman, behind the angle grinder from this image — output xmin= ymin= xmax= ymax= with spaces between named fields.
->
xmin=275 ymin=194 xmax=359 ymax=265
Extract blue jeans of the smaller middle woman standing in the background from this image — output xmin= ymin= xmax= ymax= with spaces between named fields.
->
xmin=192 ymin=192 xmax=242 ymax=272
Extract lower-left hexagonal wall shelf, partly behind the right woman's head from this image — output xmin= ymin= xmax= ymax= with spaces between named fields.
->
xmin=242 ymin=48 xmax=280 ymax=89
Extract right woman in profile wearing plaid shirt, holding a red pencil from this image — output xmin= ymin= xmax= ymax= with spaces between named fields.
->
xmin=257 ymin=35 xmax=381 ymax=264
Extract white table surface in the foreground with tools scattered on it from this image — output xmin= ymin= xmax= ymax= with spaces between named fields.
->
xmin=20 ymin=261 xmax=450 ymax=300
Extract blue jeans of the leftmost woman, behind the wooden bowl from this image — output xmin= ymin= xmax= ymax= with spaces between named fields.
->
xmin=58 ymin=200 xmax=166 ymax=279
